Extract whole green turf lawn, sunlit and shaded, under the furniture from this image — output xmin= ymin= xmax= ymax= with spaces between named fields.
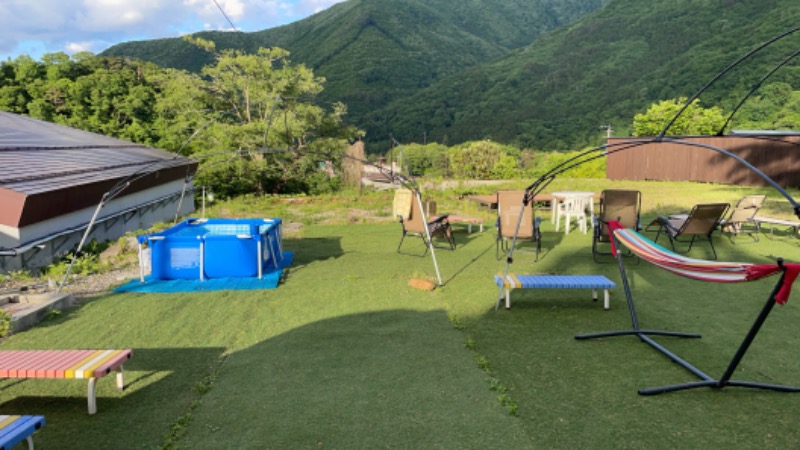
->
xmin=0 ymin=181 xmax=800 ymax=449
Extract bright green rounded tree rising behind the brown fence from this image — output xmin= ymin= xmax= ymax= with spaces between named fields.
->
xmin=633 ymin=97 xmax=725 ymax=136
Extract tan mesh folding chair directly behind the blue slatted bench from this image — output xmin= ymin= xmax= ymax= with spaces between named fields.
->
xmin=495 ymin=191 xmax=542 ymax=260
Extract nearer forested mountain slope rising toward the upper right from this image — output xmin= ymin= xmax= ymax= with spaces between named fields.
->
xmin=378 ymin=0 xmax=800 ymax=149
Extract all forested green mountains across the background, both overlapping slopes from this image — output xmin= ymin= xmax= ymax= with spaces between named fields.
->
xmin=103 ymin=0 xmax=800 ymax=152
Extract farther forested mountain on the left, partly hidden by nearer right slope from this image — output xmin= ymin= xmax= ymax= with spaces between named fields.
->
xmin=102 ymin=0 xmax=608 ymax=148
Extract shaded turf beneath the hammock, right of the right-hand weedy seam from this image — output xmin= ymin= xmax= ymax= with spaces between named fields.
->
xmin=476 ymin=235 xmax=800 ymax=448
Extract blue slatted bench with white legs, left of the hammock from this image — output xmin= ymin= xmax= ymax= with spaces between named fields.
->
xmin=494 ymin=273 xmax=616 ymax=310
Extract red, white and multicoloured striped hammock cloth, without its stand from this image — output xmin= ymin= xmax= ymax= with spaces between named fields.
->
xmin=608 ymin=221 xmax=800 ymax=304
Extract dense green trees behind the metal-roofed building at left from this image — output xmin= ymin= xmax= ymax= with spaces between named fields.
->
xmin=0 ymin=48 xmax=363 ymax=197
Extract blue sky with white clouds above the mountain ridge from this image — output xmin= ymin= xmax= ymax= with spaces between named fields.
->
xmin=0 ymin=0 xmax=344 ymax=61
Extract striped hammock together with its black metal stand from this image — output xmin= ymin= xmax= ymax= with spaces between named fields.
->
xmin=575 ymin=221 xmax=800 ymax=395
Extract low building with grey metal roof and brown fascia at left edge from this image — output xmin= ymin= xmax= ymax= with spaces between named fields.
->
xmin=0 ymin=111 xmax=197 ymax=273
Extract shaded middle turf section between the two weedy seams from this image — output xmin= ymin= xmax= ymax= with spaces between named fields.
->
xmin=173 ymin=310 xmax=526 ymax=448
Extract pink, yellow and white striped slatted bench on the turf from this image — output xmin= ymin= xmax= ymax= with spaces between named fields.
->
xmin=0 ymin=349 xmax=133 ymax=414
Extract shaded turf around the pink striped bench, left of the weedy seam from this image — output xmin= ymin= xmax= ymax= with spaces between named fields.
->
xmin=0 ymin=348 xmax=224 ymax=448
